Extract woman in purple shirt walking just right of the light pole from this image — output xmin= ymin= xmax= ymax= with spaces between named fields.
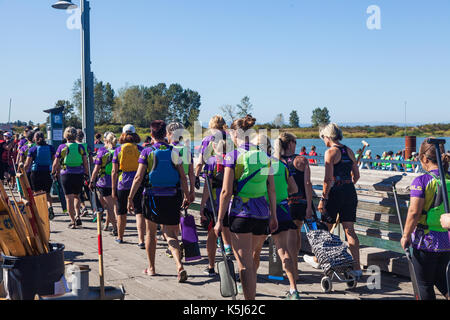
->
xmin=89 ymin=132 xmax=118 ymax=237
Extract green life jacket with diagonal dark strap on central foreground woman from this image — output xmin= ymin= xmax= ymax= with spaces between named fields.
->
xmin=234 ymin=147 xmax=270 ymax=199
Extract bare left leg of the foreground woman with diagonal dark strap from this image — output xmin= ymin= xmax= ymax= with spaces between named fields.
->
xmin=231 ymin=233 xmax=256 ymax=300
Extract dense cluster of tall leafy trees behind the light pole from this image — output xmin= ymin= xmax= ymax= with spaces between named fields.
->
xmin=55 ymin=78 xmax=201 ymax=128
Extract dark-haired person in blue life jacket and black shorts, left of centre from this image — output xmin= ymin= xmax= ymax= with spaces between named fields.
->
xmin=128 ymin=120 xmax=190 ymax=282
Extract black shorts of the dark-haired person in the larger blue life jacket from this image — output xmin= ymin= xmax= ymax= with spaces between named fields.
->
xmin=144 ymin=190 xmax=183 ymax=226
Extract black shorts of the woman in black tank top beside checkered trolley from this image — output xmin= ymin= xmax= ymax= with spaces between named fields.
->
xmin=322 ymin=183 xmax=358 ymax=224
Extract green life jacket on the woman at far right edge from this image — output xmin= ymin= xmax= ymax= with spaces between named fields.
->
xmin=418 ymin=172 xmax=450 ymax=232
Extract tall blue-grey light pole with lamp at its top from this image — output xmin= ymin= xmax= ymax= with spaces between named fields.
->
xmin=52 ymin=0 xmax=94 ymax=151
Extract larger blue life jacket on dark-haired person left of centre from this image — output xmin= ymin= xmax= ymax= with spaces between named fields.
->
xmin=147 ymin=144 xmax=180 ymax=188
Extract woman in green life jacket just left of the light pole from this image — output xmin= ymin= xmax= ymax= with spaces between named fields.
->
xmin=52 ymin=127 xmax=89 ymax=229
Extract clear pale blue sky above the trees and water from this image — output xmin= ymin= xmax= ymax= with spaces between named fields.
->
xmin=0 ymin=0 xmax=450 ymax=123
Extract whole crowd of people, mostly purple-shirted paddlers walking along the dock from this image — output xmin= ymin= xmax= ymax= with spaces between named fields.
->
xmin=0 ymin=115 xmax=450 ymax=300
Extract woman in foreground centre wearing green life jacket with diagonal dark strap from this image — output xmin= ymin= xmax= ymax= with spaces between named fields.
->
xmin=214 ymin=115 xmax=278 ymax=300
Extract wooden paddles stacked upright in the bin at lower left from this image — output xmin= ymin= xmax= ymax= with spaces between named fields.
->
xmin=0 ymin=168 xmax=49 ymax=257
